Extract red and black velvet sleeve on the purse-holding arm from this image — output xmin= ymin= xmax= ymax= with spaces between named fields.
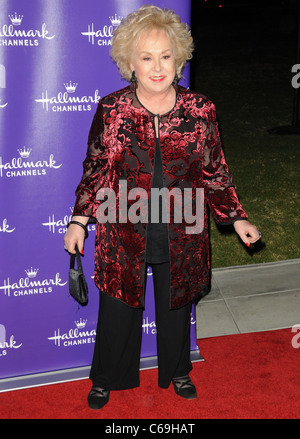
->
xmin=73 ymin=101 xmax=108 ymax=217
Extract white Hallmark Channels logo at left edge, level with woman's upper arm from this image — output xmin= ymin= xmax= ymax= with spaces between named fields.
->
xmin=0 ymin=146 xmax=62 ymax=178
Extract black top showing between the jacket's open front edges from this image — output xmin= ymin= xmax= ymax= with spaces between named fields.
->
xmin=146 ymin=138 xmax=169 ymax=264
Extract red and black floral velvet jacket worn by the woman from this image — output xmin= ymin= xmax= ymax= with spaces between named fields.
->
xmin=73 ymin=86 xmax=247 ymax=308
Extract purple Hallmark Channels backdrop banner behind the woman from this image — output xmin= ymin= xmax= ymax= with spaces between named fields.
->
xmin=0 ymin=0 xmax=198 ymax=384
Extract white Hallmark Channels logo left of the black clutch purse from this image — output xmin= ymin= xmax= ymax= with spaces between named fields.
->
xmin=0 ymin=267 xmax=68 ymax=297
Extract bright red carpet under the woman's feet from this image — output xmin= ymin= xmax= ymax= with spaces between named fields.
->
xmin=0 ymin=329 xmax=300 ymax=419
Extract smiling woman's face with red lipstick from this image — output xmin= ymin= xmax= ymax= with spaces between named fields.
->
xmin=130 ymin=29 xmax=176 ymax=97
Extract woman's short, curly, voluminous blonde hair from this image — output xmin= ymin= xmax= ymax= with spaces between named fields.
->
xmin=110 ymin=5 xmax=194 ymax=81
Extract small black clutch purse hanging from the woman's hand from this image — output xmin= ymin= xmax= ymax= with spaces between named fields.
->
xmin=69 ymin=245 xmax=88 ymax=306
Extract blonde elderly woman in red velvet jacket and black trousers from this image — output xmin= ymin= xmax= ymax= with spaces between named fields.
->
xmin=65 ymin=6 xmax=260 ymax=409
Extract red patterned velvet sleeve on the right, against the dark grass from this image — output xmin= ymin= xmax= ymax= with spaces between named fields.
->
xmin=203 ymin=101 xmax=248 ymax=224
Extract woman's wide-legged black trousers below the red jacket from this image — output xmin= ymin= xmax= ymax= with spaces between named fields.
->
xmin=90 ymin=263 xmax=192 ymax=390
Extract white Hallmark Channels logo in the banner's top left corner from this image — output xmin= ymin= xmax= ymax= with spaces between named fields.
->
xmin=0 ymin=12 xmax=55 ymax=46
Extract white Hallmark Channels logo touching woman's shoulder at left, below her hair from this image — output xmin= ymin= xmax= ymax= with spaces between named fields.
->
xmin=35 ymin=81 xmax=100 ymax=112
